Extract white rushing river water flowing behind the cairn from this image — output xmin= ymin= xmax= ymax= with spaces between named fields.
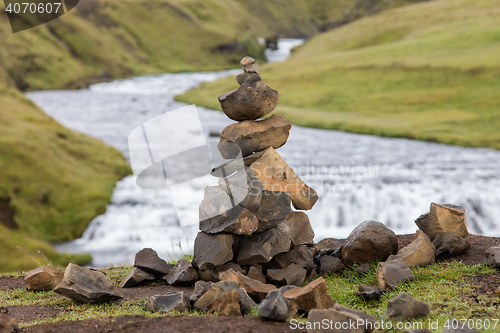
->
xmin=27 ymin=40 xmax=500 ymax=267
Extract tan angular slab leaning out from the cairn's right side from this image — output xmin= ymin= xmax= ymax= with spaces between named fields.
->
xmin=250 ymin=147 xmax=318 ymax=210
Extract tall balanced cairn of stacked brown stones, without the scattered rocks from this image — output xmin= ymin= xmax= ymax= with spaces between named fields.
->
xmin=193 ymin=57 xmax=318 ymax=286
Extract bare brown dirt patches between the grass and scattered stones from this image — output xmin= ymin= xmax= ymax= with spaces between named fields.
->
xmin=0 ymin=234 xmax=500 ymax=333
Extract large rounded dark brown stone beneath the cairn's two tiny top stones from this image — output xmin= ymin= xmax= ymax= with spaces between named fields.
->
xmin=219 ymin=81 xmax=279 ymax=121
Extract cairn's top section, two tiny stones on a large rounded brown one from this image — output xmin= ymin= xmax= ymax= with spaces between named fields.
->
xmin=219 ymin=56 xmax=279 ymax=121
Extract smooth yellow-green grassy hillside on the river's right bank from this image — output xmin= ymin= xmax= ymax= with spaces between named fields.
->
xmin=178 ymin=0 xmax=500 ymax=149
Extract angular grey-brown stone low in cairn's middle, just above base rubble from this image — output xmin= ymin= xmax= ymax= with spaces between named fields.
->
xmin=236 ymin=223 xmax=291 ymax=265
